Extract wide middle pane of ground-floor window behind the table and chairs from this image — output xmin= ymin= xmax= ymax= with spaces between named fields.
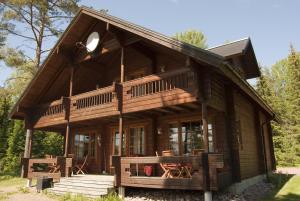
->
xmin=181 ymin=121 xmax=203 ymax=154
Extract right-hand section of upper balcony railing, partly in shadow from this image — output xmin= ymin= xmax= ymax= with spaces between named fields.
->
xmin=123 ymin=69 xmax=197 ymax=113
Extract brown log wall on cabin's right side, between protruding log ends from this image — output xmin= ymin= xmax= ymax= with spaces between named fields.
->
xmin=234 ymin=92 xmax=261 ymax=179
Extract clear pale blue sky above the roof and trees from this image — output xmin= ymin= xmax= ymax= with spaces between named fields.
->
xmin=0 ymin=0 xmax=300 ymax=86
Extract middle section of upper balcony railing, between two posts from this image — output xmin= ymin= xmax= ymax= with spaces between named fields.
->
xmin=70 ymin=85 xmax=119 ymax=122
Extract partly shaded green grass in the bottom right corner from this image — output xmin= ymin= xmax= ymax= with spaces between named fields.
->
xmin=264 ymin=174 xmax=300 ymax=201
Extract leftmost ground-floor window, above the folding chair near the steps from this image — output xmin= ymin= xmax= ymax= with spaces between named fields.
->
xmin=74 ymin=134 xmax=95 ymax=159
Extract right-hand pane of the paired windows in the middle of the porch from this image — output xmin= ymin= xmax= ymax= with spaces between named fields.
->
xmin=129 ymin=127 xmax=145 ymax=156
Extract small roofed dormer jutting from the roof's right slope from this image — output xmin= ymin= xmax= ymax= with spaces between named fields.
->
xmin=208 ymin=38 xmax=260 ymax=80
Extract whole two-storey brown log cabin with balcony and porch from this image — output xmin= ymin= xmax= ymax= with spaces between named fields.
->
xmin=11 ymin=7 xmax=276 ymax=199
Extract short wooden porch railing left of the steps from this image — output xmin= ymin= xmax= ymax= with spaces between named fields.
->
xmin=21 ymin=156 xmax=72 ymax=180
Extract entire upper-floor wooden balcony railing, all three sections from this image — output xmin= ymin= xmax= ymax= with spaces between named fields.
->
xmin=33 ymin=68 xmax=198 ymax=128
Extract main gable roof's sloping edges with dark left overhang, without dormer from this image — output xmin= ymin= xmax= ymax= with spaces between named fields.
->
xmin=11 ymin=7 xmax=274 ymax=119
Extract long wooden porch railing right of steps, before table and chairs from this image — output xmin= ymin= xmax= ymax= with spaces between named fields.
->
xmin=120 ymin=153 xmax=224 ymax=190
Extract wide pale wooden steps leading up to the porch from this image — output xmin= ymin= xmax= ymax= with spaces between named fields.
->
xmin=48 ymin=175 xmax=114 ymax=198
